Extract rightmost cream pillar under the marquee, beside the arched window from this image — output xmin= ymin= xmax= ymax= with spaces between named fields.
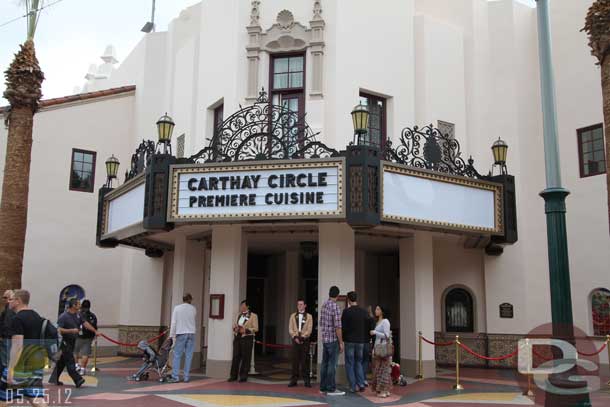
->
xmin=399 ymin=232 xmax=436 ymax=377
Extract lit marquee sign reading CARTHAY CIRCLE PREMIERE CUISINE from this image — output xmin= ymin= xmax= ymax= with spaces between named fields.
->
xmin=168 ymin=158 xmax=345 ymax=222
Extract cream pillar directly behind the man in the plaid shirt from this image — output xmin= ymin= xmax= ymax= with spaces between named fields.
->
xmin=318 ymin=223 xmax=356 ymax=383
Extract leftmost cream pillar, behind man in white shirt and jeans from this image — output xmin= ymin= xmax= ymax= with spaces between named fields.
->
xmin=172 ymin=236 xmax=205 ymax=369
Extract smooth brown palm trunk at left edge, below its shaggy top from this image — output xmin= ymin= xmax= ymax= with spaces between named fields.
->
xmin=0 ymin=107 xmax=34 ymax=292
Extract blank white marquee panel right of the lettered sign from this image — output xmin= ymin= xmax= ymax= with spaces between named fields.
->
xmin=381 ymin=162 xmax=504 ymax=235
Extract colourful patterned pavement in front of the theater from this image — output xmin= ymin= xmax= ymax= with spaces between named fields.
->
xmin=38 ymin=357 xmax=610 ymax=407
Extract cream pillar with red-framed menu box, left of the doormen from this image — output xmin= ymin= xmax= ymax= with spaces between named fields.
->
xmin=206 ymin=225 xmax=248 ymax=378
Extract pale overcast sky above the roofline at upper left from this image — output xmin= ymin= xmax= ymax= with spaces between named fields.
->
xmin=0 ymin=0 xmax=534 ymax=106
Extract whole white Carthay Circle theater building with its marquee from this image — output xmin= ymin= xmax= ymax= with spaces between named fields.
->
xmin=2 ymin=0 xmax=610 ymax=377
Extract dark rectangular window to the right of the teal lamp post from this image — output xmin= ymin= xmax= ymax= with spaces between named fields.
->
xmin=576 ymin=124 xmax=606 ymax=178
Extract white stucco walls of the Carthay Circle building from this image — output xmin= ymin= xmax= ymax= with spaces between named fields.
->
xmin=0 ymin=0 xmax=610 ymax=376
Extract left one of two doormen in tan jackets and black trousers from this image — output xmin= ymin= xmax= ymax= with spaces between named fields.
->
xmin=228 ymin=300 xmax=258 ymax=382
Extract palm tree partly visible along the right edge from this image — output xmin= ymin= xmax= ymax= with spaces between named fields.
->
xmin=582 ymin=0 xmax=610 ymax=233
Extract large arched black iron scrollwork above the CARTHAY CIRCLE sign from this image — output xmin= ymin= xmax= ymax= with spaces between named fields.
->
xmin=190 ymin=90 xmax=339 ymax=163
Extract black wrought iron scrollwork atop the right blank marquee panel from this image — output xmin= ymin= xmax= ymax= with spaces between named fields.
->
xmin=382 ymin=125 xmax=481 ymax=178
